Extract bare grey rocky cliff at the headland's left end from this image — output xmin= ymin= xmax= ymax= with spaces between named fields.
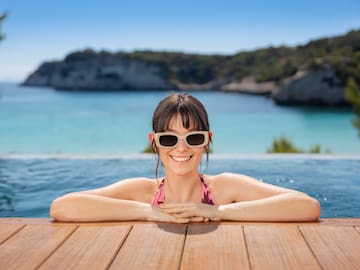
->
xmin=24 ymin=56 xmax=171 ymax=90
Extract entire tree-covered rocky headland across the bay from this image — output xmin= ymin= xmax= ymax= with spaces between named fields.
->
xmin=23 ymin=30 xmax=360 ymax=106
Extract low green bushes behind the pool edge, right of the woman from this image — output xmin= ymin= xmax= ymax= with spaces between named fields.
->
xmin=266 ymin=137 xmax=330 ymax=154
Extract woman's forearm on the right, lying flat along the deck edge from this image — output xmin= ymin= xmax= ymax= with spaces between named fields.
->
xmin=218 ymin=193 xmax=320 ymax=221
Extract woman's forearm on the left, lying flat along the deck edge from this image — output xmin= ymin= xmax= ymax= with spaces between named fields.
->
xmin=50 ymin=193 xmax=151 ymax=222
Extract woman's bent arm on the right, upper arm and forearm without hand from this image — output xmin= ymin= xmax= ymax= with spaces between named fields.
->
xmin=218 ymin=173 xmax=320 ymax=221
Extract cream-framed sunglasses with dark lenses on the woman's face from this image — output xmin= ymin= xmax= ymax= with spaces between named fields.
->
xmin=154 ymin=131 xmax=209 ymax=148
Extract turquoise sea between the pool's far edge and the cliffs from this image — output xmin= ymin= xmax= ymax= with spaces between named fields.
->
xmin=0 ymin=83 xmax=360 ymax=154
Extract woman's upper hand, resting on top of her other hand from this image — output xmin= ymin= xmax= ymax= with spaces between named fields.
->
xmin=159 ymin=203 xmax=221 ymax=222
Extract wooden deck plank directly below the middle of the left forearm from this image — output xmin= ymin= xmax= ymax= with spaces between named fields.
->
xmin=40 ymin=225 xmax=131 ymax=270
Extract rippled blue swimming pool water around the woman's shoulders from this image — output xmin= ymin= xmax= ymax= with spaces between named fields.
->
xmin=0 ymin=155 xmax=360 ymax=218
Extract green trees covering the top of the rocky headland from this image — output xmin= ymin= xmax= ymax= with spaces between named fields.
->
xmin=59 ymin=30 xmax=360 ymax=86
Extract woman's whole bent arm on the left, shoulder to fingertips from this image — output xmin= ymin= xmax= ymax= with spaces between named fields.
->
xmin=50 ymin=179 xmax=203 ymax=223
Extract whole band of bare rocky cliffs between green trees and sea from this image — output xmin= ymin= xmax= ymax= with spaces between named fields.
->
xmin=24 ymin=58 xmax=347 ymax=106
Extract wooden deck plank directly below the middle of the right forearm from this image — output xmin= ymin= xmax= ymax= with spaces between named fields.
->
xmin=244 ymin=225 xmax=320 ymax=270
